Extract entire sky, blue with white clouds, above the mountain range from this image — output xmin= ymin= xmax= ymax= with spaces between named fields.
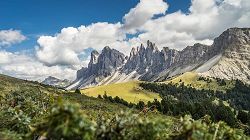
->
xmin=0 ymin=0 xmax=250 ymax=80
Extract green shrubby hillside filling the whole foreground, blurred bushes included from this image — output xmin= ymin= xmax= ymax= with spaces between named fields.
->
xmin=0 ymin=76 xmax=249 ymax=140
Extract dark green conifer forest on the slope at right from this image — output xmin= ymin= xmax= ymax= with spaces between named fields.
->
xmin=140 ymin=80 xmax=250 ymax=134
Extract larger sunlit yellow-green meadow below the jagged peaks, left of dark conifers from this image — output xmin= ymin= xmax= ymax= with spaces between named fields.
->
xmin=81 ymin=81 xmax=161 ymax=103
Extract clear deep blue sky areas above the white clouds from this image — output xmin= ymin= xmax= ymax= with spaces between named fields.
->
xmin=0 ymin=0 xmax=191 ymax=52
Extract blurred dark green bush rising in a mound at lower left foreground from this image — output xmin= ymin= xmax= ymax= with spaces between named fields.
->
xmin=33 ymin=102 xmax=94 ymax=140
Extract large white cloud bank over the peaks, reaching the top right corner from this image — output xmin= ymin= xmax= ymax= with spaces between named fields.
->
xmin=37 ymin=0 xmax=250 ymax=66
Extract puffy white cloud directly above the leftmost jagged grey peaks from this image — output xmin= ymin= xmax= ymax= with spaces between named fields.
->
xmin=36 ymin=22 xmax=131 ymax=66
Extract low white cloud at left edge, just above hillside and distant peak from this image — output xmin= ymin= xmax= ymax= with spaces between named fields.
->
xmin=0 ymin=51 xmax=76 ymax=81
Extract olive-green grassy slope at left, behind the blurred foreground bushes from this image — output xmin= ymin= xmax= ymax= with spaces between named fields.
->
xmin=0 ymin=75 xmax=135 ymax=117
